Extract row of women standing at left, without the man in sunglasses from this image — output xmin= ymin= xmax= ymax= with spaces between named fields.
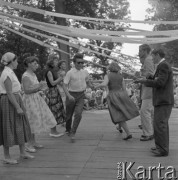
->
xmin=0 ymin=52 xmax=74 ymax=164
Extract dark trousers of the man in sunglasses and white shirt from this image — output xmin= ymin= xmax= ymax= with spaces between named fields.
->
xmin=66 ymin=92 xmax=85 ymax=134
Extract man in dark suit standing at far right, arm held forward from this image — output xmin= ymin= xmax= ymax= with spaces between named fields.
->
xmin=135 ymin=49 xmax=174 ymax=156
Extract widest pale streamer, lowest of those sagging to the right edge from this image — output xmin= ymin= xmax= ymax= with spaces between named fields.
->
xmin=0 ymin=12 xmax=178 ymax=44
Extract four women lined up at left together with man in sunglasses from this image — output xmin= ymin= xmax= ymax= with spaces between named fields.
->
xmin=0 ymin=52 xmax=97 ymax=164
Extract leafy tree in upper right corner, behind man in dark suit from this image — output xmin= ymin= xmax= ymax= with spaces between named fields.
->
xmin=148 ymin=0 xmax=178 ymax=67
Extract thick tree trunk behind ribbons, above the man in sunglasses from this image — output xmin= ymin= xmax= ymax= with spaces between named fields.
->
xmin=54 ymin=0 xmax=70 ymax=70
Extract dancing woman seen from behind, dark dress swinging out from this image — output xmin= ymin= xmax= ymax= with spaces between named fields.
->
xmin=95 ymin=62 xmax=139 ymax=140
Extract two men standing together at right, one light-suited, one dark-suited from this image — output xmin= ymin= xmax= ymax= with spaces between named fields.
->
xmin=135 ymin=44 xmax=174 ymax=157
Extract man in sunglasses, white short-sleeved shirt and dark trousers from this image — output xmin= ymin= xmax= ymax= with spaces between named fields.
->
xmin=64 ymin=53 xmax=93 ymax=141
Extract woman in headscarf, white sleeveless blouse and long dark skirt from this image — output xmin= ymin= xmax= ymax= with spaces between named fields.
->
xmin=0 ymin=52 xmax=34 ymax=164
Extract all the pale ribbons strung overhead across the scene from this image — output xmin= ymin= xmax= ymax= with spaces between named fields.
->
xmin=0 ymin=0 xmax=178 ymax=70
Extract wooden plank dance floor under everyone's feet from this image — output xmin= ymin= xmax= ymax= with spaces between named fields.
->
xmin=0 ymin=109 xmax=178 ymax=180
